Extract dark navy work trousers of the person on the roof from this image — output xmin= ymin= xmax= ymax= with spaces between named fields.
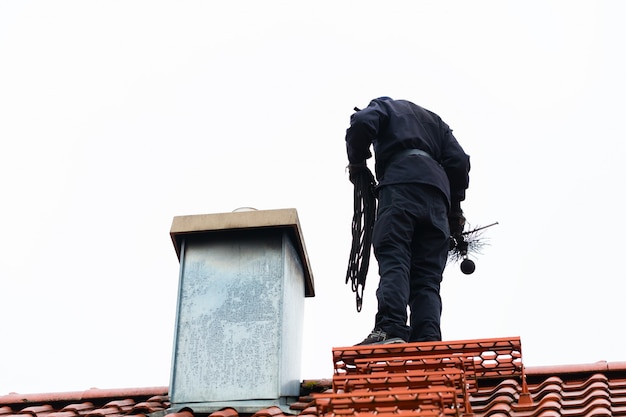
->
xmin=372 ymin=184 xmax=450 ymax=342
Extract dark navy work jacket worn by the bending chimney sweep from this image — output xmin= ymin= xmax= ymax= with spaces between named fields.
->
xmin=346 ymin=98 xmax=470 ymax=210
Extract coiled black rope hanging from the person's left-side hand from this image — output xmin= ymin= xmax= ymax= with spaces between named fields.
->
xmin=346 ymin=167 xmax=376 ymax=312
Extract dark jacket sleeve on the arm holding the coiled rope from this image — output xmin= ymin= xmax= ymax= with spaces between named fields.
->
xmin=346 ymin=101 xmax=388 ymax=164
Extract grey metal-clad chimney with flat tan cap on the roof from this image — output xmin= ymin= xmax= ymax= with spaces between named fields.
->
xmin=169 ymin=209 xmax=315 ymax=413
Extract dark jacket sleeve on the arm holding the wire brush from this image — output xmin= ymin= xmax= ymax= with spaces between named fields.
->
xmin=440 ymin=124 xmax=470 ymax=212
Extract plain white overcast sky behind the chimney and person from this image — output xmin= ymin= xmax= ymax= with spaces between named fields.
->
xmin=0 ymin=0 xmax=626 ymax=395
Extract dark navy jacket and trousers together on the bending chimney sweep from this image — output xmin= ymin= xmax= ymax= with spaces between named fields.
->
xmin=346 ymin=97 xmax=470 ymax=342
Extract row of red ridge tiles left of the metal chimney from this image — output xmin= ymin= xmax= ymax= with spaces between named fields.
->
xmin=0 ymin=387 xmax=169 ymax=405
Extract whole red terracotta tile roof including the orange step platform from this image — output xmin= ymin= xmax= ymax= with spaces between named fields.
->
xmin=0 ymin=338 xmax=626 ymax=417
